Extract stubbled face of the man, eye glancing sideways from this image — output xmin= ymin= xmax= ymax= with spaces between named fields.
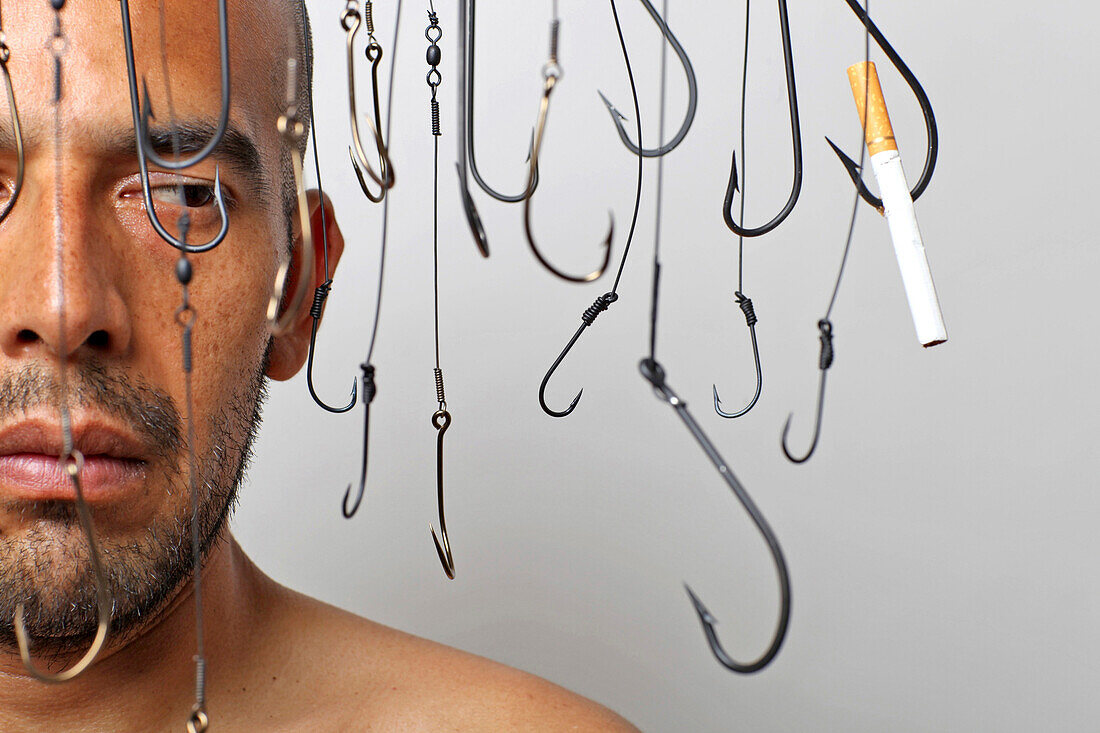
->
xmin=0 ymin=0 xmax=300 ymax=652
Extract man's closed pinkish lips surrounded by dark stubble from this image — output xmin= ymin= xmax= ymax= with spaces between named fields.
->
xmin=0 ymin=415 xmax=147 ymax=503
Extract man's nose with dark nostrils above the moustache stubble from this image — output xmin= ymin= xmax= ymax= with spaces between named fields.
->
xmin=0 ymin=174 xmax=131 ymax=360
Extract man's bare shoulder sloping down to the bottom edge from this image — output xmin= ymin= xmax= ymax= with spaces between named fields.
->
xmin=259 ymin=589 xmax=637 ymax=733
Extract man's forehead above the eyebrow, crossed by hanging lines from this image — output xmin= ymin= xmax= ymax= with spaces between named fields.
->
xmin=2 ymin=0 xmax=297 ymax=164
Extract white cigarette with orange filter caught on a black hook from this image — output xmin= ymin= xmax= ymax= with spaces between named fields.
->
xmin=848 ymin=62 xmax=947 ymax=348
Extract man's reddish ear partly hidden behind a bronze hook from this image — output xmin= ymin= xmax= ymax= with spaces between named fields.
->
xmin=267 ymin=189 xmax=344 ymax=381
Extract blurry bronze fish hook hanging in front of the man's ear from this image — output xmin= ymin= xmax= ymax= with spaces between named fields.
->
xmin=267 ymin=58 xmax=317 ymax=336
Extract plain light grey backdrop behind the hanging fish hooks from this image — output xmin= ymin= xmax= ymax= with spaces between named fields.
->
xmin=227 ymin=0 xmax=1100 ymax=731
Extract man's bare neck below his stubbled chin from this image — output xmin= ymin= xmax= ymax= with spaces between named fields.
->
xmin=0 ymin=532 xmax=271 ymax=732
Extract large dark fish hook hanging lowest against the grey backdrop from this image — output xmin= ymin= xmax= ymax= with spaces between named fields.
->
xmin=638 ymin=358 xmax=791 ymax=675
